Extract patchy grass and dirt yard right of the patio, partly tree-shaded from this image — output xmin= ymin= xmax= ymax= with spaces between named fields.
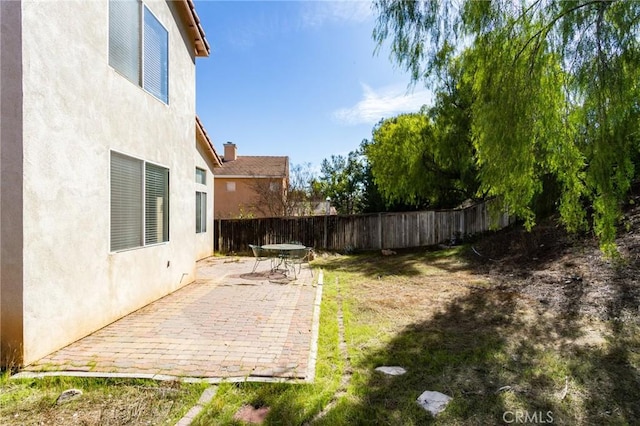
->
xmin=317 ymin=191 xmax=640 ymax=425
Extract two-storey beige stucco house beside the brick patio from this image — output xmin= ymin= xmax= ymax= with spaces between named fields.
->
xmin=0 ymin=0 xmax=219 ymax=365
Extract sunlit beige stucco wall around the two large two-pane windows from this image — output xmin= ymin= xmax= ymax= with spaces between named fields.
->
xmin=22 ymin=0 xmax=196 ymax=363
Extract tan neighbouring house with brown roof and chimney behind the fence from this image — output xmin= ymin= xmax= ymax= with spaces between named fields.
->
xmin=214 ymin=142 xmax=289 ymax=218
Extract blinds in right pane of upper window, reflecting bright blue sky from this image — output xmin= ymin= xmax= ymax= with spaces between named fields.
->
xmin=143 ymin=7 xmax=169 ymax=103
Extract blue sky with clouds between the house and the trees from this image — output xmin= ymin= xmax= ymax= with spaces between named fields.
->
xmin=195 ymin=0 xmax=430 ymax=170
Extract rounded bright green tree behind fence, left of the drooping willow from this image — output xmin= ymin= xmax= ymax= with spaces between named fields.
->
xmin=364 ymin=56 xmax=479 ymax=208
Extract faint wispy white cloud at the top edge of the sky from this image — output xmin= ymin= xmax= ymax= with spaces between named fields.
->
xmin=302 ymin=0 xmax=373 ymax=27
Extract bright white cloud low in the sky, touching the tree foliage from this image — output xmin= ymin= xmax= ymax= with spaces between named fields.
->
xmin=333 ymin=84 xmax=432 ymax=125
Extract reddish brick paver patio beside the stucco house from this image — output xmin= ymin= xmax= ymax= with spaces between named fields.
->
xmin=22 ymin=258 xmax=321 ymax=382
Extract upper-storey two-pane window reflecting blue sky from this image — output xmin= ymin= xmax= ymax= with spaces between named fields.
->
xmin=109 ymin=0 xmax=169 ymax=103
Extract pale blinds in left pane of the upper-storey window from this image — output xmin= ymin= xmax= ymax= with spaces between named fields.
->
xmin=109 ymin=0 xmax=140 ymax=85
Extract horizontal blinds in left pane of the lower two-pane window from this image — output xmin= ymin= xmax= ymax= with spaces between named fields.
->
xmin=111 ymin=152 xmax=143 ymax=251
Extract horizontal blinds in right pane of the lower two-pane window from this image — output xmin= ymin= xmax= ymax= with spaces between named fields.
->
xmin=144 ymin=163 xmax=169 ymax=244
